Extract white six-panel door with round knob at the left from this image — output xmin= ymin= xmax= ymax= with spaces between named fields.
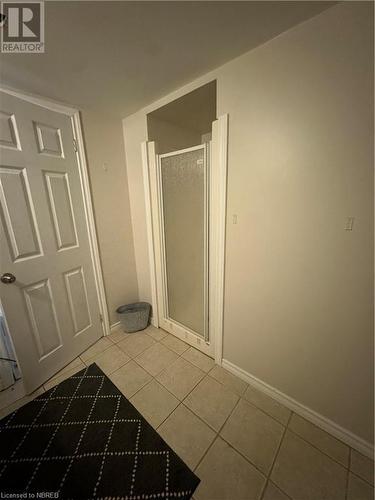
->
xmin=0 ymin=92 xmax=103 ymax=392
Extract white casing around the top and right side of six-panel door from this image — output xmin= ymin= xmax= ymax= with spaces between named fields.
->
xmin=0 ymin=85 xmax=110 ymax=344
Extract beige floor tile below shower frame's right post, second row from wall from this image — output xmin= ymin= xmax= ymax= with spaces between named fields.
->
xmin=184 ymin=377 xmax=239 ymax=430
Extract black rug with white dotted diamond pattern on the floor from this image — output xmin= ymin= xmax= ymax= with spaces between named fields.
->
xmin=0 ymin=364 xmax=199 ymax=500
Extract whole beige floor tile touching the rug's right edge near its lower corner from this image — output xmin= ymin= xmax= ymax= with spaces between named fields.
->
xmin=158 ymin=405 xmax=216 ymax=469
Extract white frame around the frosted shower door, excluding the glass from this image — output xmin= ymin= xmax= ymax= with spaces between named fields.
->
xmin=142 ymin=115 xmax=228 ymax=365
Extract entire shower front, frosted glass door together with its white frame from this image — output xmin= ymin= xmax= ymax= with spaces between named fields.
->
xmin=142 ymin=115 xmax=227 ymax=360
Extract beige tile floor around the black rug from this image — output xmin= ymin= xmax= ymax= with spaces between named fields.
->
xmin=0 ymin=326 xmax=374 ymax=500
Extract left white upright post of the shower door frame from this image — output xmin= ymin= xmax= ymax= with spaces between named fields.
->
xmin=141 ymin=142 xmax=159 ymax=328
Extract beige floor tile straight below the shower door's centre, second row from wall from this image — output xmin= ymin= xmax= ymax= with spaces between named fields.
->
xmin=156 ymin=358 xmax=205 ymax=400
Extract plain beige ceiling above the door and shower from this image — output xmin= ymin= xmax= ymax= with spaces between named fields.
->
xmin=0 ymin=1 xmax=335 ymax=117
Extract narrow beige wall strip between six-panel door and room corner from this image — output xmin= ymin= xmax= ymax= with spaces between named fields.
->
xmin=82 ymin=111 xmax=138 ymax=324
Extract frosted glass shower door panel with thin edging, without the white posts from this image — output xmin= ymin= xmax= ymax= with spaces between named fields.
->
xmin=159 ymin=145 xmax=208 ymax=340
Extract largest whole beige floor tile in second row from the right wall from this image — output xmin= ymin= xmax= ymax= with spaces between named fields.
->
xmin=220 ymin=399 xmax=285 ymax=474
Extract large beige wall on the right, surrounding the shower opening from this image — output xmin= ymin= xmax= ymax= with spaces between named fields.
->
xmin=124 ymin=2 xmax=374 ymax=441
